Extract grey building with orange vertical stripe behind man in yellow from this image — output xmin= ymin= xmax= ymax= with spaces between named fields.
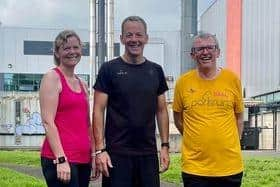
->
xmin=200 ymin=0 xmax=280 ymax=150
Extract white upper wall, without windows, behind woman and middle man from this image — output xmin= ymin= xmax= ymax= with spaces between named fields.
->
xmin=0 ymin=27 xmax=180 ymax=82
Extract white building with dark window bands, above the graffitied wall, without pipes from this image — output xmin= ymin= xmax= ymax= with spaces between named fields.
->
xmin=0 ymin=27 xmax=180 ymax=92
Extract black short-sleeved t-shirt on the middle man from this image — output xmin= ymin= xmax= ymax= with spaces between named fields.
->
xmin=94 ymin=57 xmax=168 ymax=155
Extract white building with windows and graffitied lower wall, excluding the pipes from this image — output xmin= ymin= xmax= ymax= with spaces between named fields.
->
xmin=0 ymin=27 xmax=181 ymax=148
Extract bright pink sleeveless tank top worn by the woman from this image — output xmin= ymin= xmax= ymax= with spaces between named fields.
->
xmin=41 ymin=68 xmax=91 ymax=163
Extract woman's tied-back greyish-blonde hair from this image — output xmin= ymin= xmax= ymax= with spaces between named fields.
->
xmin=53 ymin=30 xmax=82 ymax=66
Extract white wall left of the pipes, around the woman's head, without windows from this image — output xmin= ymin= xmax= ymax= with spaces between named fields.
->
xmin=0 ymin=27 xmax=89 ymax=74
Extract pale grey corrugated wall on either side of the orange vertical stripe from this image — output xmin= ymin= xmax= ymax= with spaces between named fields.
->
xmin=200 ymin=0 xmax=280 ymax=97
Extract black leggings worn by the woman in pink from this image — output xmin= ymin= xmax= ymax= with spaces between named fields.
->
xmin=41 ymin=157 xmax=91 ymax=187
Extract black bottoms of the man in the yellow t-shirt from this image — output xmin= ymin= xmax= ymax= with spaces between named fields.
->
xmin=182 ymin=172 xmax=243 ymax=187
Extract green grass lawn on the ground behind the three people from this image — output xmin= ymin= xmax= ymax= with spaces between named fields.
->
xmin=0 ymin=151 xmax=280 ymax=187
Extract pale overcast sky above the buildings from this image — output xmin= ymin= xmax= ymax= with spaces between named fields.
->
xmin=0 ymin=0 xmax=213 ymax=30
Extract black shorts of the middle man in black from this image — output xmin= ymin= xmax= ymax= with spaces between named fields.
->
xmin=102 ymin=154 xmax=160 ymax=187
